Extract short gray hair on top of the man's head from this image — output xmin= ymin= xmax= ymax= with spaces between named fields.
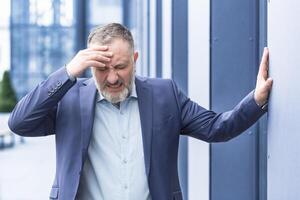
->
xmin=87 ymin=23 xmax=134 ymax=50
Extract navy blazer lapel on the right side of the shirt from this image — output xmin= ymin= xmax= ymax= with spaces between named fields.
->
xmin=135 ymin=77 xmax=153 ymax=176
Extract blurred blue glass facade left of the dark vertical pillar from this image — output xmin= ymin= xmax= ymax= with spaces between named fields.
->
xmin=11 ymin=0 xmax=74 ymax=98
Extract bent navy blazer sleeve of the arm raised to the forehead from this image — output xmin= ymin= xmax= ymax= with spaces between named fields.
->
xmin=8 ymin=67 xmax=76 ymax=136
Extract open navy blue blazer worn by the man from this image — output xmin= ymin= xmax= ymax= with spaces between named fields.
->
xmin=9 ymin=68 xmax=264 ymax=200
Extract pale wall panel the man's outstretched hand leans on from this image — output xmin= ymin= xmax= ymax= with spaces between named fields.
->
xmin=268 ymin=0 xmax=300 ymax=200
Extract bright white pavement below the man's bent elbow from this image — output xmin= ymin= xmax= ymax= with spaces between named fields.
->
xmin=0 ymin=136 xmax=55 ymax=200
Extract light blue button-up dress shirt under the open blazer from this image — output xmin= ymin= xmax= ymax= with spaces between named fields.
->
xmin=76 ymin=82 xmax=151 ymax=200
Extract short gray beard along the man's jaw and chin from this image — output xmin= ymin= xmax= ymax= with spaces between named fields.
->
xmin=92 ymin=70 xmax=135 ymax=104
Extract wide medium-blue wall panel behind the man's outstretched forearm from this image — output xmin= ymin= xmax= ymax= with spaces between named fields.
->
xmin=210 ymin=0 xmax=258 ymax=200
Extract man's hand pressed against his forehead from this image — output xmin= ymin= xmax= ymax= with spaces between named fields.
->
xmin=66 ymin=45 xmax=113 ymax=77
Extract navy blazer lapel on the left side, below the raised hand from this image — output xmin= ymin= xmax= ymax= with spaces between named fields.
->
xmin=80 ymin=79 xmax=97 ymax=152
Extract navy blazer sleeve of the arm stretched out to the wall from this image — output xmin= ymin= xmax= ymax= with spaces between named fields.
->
xmin=173 ymin=80 xmax=266 ymax=142
